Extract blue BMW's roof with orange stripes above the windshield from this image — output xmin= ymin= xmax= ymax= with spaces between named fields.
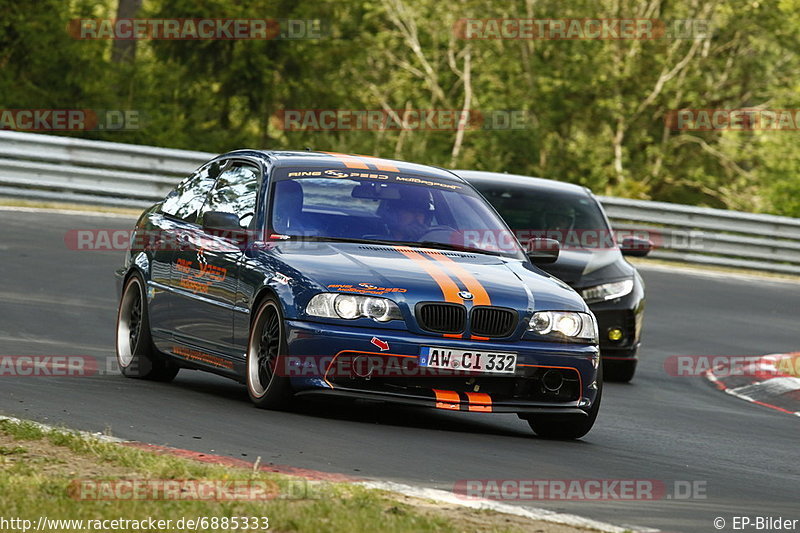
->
xmin=224 ymin=150 xmax=464 ymax=182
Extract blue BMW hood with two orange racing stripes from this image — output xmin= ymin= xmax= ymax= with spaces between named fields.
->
xmin=273 ymin=242 xmax=586 ymax=311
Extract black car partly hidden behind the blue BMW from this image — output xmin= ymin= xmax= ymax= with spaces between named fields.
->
xmin=456 ymin=170 xmax=652 ymax=382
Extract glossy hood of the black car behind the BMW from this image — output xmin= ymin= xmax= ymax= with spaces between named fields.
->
xmin=541 ymin=248 xmax=634 ymax=288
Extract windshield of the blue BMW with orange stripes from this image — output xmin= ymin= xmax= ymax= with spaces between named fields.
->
xmin=270 ymin=169 xmax=524 ymax=258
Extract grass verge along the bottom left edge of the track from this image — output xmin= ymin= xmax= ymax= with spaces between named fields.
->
xmin=0 ymin=420 xmax=586 ymax=533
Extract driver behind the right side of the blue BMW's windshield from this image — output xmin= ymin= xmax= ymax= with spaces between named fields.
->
xmin=377 ymin=185 xmax=433 ymax=241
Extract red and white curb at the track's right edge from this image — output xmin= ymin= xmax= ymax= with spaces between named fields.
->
xmin=703 ymin=352 xmax=800 ymax=416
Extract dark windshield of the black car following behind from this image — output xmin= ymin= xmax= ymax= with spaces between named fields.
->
xmin=473 ymin=182 xmax=614 ymax=249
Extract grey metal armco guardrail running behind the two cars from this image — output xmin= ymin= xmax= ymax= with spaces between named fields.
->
xmin=0 ymin=131 xmax=800 ymax=274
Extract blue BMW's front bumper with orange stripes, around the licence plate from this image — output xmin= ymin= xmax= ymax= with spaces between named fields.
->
xmin=284 ymin=320 xmax=599 ymax=415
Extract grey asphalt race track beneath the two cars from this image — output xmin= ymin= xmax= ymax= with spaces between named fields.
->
xmin=0 ymin=210 xmax=800 ymax=531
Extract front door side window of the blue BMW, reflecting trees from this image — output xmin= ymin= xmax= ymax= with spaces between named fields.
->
xmin=201 ymin=162 xmax=261 ymax=227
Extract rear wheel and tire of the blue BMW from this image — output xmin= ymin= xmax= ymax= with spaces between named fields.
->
xmin=117 ymin=274 xmax=180 ymax=382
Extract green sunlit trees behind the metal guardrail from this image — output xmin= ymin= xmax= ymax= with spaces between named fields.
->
xmin=0 ymin=0 xmax=800 ymax=216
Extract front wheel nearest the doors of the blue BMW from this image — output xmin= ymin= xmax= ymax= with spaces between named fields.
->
xmin=247 ymin=297 xmax=293 ymax=409
